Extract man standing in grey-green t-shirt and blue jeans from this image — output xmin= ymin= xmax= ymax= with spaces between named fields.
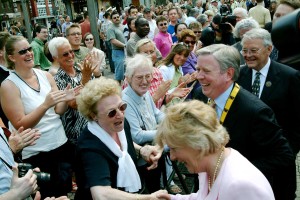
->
xmin=107 ymin=11 xmax=125 ymax=83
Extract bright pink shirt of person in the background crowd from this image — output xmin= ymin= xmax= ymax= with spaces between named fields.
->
xmin=154 ymin=32 xmax=173 ymax=58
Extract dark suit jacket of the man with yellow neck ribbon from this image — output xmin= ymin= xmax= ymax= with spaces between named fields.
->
xmin=198 ymin=88 xmax=294 ymax=173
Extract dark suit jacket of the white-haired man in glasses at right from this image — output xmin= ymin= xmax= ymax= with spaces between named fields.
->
xmin=238 ymin=61 xmax=300 ymax=155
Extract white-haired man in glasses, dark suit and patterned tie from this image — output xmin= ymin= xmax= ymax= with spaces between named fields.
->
xmin=238 ymin=29 xmax=300 ymax=199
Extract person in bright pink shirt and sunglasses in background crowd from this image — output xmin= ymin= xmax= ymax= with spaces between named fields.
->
xmin=154 ymin=15 xmax=173 ymax=58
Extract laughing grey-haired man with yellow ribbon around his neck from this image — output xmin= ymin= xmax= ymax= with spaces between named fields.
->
xmin=196 ymin=44 xmax=294 ymax=200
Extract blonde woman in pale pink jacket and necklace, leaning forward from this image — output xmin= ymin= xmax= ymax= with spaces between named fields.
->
xmin=156 ymin=100 xmax=275 ymax=200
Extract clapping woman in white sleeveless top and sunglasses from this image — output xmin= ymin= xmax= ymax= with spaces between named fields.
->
xmin=1 ymin=36 xmax=75 ymax=196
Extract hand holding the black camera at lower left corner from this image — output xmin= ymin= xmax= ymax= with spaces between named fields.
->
xmin=10 ymin=166 xmax=38 ymax=199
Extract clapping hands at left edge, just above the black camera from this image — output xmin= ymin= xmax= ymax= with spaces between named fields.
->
xmin=8 ymin=126 xmax=41 ymax=153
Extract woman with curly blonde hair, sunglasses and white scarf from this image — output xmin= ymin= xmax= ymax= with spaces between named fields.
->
xmin=75 ymin=77 xmax=165 ymax=200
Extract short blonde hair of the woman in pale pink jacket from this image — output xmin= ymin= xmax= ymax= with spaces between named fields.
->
xmin=156 ymin=100 xmax=229 ymax=155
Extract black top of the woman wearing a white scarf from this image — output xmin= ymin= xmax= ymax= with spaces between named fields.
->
xmin=75 ymin=120 xmax=136 ymax=200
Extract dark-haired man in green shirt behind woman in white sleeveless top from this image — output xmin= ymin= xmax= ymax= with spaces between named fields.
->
xmin=30 ymin=25 xmax=51 ymax=71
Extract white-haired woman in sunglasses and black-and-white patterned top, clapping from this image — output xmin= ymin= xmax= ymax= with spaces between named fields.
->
xmin=49 ymin=37 xmax=99 ymax=144
